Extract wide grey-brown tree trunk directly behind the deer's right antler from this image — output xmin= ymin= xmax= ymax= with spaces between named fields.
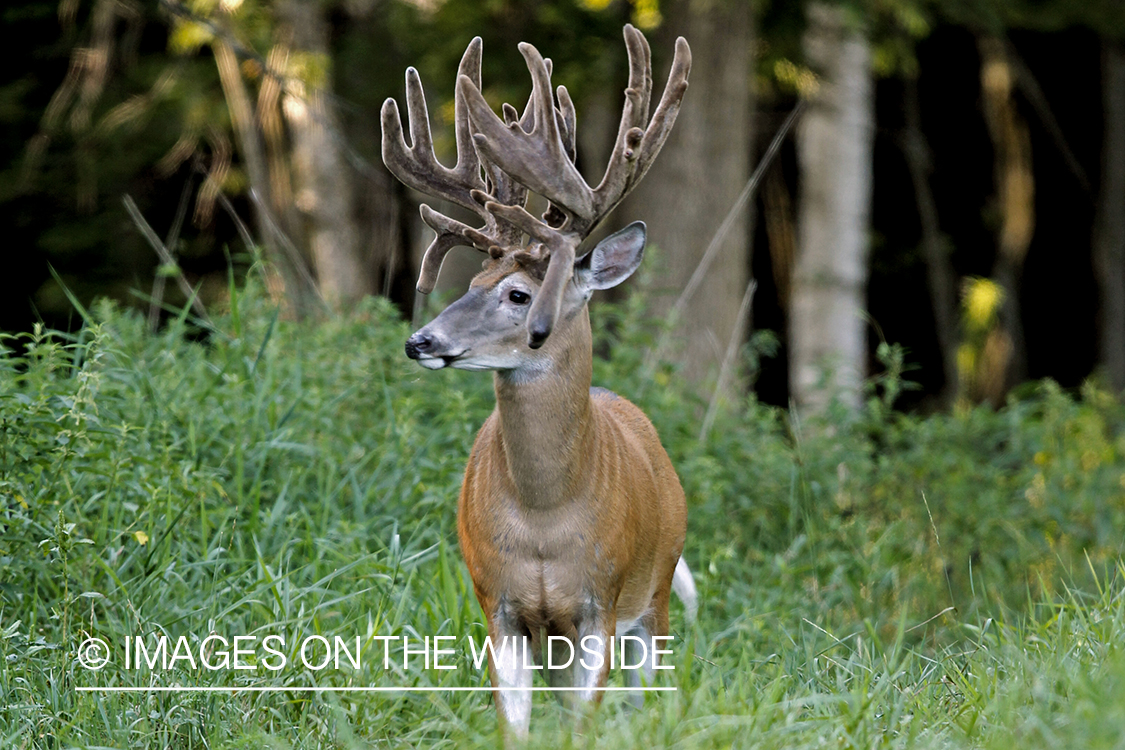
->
xmin=619 ymin=0 xmax=753 ymax=388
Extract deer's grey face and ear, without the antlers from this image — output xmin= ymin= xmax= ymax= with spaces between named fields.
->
xmin=406 ymin=222 xmax=645 ymax=372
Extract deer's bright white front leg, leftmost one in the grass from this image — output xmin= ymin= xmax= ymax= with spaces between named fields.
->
xmin=488 ymin=607 xmax=536 ymax=740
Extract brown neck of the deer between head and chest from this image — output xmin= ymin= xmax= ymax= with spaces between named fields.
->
xmin=494 ymin=307 xmax=594 ymax=508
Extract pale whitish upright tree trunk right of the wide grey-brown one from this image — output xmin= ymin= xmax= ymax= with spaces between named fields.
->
xmin=789 ymin=3 xmax=874 ymax=413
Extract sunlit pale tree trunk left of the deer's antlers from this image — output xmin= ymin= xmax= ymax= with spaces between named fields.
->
xmin=281 ymin=0 xmax=375 ymax=308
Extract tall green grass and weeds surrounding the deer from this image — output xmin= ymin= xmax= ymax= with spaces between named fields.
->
xmin=0 ymin=277 xmax=1125 ymax=748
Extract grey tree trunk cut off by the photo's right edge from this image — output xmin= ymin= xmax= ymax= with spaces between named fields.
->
xmin=1094 ymin=40 xmax=1125 ymax=394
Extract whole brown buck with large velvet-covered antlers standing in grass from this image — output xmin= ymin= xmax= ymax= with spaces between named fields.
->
xmin=383 ymin=26 xmax=695 ymax=737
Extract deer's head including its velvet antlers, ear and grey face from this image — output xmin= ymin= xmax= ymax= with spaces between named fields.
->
xmin=383 ymin=25 xmax=691 ymax=370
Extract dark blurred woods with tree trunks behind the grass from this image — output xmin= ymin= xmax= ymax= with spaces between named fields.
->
xmin=0 ymin=0 xmax=1125 ymax=409
